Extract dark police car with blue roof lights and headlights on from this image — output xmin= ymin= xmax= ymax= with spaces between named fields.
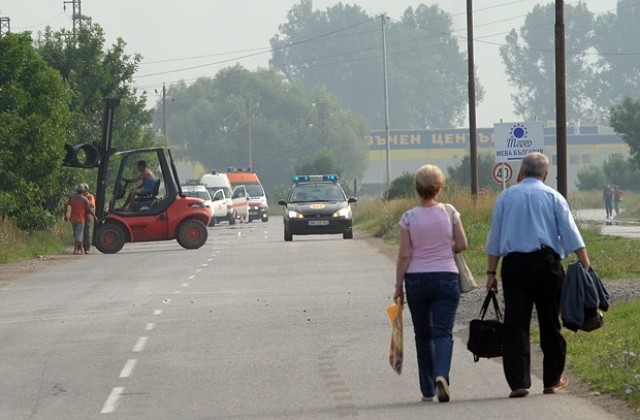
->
xmin=278 ymin=174 xmax=357 ymax=241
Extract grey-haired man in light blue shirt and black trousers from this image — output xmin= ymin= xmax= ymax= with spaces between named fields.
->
xmin=485 ymin=153 xmax=591 ymax=398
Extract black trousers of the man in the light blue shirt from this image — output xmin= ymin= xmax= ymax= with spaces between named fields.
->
xmin=501 ymin=247 xmax=567 ymax=390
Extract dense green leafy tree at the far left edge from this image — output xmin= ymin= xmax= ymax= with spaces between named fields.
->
xmin=0 ymin=33 xmax=69 ymax=230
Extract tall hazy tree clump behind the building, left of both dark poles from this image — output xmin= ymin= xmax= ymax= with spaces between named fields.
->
xmin=270 ymin=0 xmax=483 ymax=129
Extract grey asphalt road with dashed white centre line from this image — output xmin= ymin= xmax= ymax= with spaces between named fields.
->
xmin=0 ymin=218 xmax=615 ymax=420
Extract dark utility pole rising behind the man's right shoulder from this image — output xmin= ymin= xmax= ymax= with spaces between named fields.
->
xmin=555 ymin=0 xmax=568 ymax=198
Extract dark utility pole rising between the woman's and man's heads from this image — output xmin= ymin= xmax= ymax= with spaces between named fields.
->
xmin=467 ymin=0 xmax=478 ymax=197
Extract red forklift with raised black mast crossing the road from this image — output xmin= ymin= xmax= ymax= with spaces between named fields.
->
xmin=87 ymin=99 xmax=211 ymax=254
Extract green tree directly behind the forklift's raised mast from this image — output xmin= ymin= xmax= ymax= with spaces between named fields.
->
xmin=36 ymin=17 xmax=157 ymax=150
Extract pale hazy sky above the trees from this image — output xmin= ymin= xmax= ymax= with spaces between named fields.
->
xmin=0 ymin=0 xmax=617 ymax=128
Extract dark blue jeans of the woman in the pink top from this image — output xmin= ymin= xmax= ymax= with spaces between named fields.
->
xmin=404 ymin=272 xmax=460 ymax=397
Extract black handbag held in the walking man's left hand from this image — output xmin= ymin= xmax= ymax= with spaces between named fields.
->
xmin=467 ymin=291 xmax=504 ymax=362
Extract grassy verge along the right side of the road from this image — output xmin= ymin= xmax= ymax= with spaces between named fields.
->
xmin=354 ymin=191 xmax=640 ymax=410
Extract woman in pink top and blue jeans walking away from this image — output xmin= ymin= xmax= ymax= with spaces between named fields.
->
xmin=393 ymin=165 xmax=467 ymax=402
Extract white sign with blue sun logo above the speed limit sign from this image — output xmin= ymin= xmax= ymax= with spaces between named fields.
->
xmin=493 ymin=121 xmax=544 ymax=162
